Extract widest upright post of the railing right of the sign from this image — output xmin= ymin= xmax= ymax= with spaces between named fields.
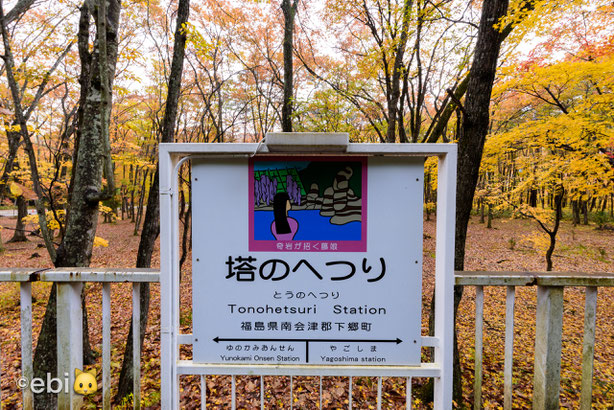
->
xmin=533 ymin=286 xmax=564 ymax=410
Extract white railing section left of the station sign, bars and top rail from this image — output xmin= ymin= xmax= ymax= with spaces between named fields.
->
xmin=0 ymin=268 xmax=160 ymax=409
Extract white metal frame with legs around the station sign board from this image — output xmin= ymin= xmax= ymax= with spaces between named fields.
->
xmin=159 ymin=139 xmax=457 ymax=409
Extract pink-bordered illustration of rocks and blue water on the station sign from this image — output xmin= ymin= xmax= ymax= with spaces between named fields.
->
xmin=249 ymin=158 xmax=367 ymax=252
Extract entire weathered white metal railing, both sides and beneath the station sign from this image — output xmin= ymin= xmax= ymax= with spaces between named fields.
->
xmin=0 ymin=268 xmax=614 ymax=409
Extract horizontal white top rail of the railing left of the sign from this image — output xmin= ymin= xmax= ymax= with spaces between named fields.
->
xmin=0 ymin=268 xmax=160 ymax=283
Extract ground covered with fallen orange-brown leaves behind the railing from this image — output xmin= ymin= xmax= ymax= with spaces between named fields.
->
xmin=0 ymin=213 xmax=614 ymax=409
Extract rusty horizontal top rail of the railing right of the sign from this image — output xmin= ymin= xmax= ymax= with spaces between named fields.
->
xmin=455 ymin=271 xmax=614 ymax=287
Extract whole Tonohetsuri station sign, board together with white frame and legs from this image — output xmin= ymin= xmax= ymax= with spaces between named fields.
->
xmin=160 ymin=133 xmax=456 ymax=409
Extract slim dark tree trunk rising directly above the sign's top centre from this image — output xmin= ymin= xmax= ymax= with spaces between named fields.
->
xmin=281 ymin=0 xmax=298 ymax=132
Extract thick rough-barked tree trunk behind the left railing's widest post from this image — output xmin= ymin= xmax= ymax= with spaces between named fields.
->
xmin=34 ymin=0 xmax=121 ymax=409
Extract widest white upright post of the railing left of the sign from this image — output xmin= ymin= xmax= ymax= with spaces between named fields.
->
xmin=56 ymin=282 xmax=83 ymax=409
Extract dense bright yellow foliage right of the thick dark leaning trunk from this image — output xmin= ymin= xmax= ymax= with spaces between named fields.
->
xmin=481 ymin=54 xmax=614 ymax=222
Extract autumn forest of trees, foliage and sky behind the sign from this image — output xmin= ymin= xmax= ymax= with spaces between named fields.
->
xmin=0 ymin=0 xmax=614 ymax=408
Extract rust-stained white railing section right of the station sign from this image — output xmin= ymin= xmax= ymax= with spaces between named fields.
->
xmin=456 ymin=272 xmax=614 ymax=410
